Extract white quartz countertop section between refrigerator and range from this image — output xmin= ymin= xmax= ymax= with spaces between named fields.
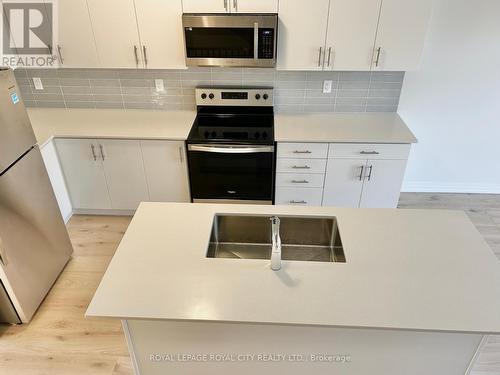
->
xmin=28 ymin=108 xmax=196 ymax=145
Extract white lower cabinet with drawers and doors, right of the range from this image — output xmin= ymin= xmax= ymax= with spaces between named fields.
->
xmin=275 ymin=143 xmax=411 ymax=208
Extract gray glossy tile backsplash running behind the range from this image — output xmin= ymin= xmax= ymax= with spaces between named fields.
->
xmin=16 ymin=68 xmax=404 ymax=112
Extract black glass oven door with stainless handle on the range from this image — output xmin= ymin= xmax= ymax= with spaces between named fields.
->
xmin=188 ymin=144 xmax=274 ymax=203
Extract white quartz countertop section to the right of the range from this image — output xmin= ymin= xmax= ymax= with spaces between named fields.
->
xmin=275 ymin=113 xmax=417 ymax=143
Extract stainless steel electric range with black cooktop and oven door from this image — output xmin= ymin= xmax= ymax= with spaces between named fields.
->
xmin=187 ymin=88 xmax=276 ymax=204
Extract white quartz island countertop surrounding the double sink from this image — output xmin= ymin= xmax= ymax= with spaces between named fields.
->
xmin=86 ymin=203 xmax=500 ymax=333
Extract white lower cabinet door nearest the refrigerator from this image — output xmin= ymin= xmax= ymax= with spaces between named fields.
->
xmin=56 ymin=139 xmax=111 ymax=210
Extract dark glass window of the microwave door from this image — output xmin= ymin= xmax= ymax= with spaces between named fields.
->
xmin=185 ymin=27 xmax=254 ymax=59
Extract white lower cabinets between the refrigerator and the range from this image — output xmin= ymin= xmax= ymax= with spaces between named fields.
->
xmin=56 ymin=138 xmax=190 ymax=213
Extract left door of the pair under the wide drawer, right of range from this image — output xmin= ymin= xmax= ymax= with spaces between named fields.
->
xmin=323 ymin=159 xmax=366 ymax=207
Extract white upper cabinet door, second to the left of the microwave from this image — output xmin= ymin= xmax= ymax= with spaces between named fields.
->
xmin=86 ymin=0 xmax=143 ymax=68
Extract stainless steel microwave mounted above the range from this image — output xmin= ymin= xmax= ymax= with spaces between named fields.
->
xmin=182 ymin=14 xmax=278 ymax=68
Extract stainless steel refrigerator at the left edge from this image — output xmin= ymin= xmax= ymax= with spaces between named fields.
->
xmin=0 ymin=68 xmax=73 ymax=323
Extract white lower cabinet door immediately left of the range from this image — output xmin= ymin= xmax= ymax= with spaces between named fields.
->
xmin=141 ymin=141 xmax=190 ymax=202
